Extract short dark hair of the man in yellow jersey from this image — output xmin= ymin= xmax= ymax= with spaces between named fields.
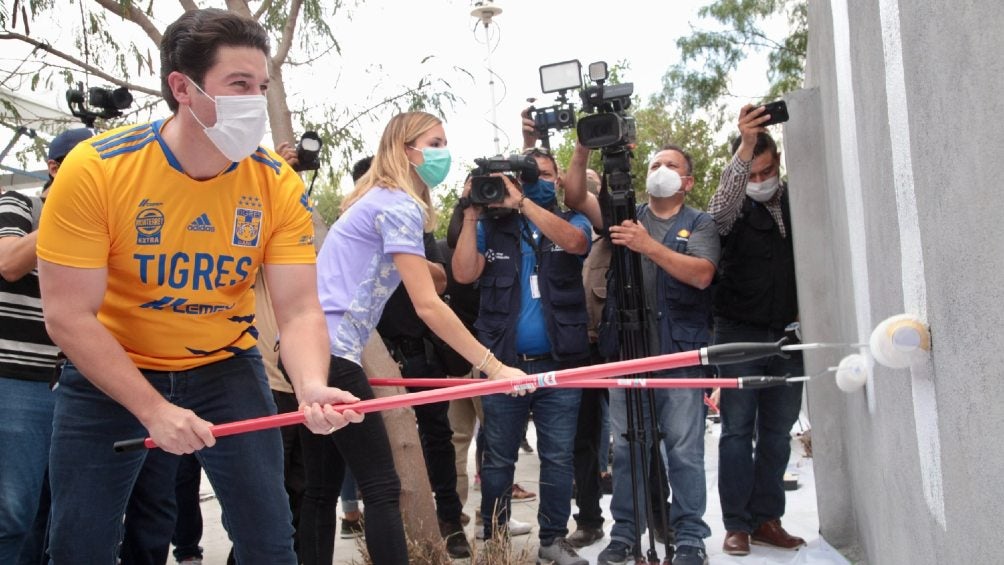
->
xmin=161 ymin=8 xmax=269 ymax=111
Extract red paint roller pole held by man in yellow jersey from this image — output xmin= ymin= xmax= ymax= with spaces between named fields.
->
xmin=114 ymin=350 xmax=702 ymax=452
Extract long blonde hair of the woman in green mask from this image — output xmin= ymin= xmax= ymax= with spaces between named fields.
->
xmin=341 ymin=111 xmax=443 ymax=232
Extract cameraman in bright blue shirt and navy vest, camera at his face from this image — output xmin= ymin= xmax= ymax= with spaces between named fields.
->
xmin=452 ymin=145 xmax=592 ymax=565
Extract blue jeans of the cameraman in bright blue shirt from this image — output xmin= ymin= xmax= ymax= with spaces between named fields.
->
xmin=481 ymin=360 xmax=581 ymax=545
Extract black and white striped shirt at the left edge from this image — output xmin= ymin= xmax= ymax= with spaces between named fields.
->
xmin=0 ymin=191 xmax=59 ymax=381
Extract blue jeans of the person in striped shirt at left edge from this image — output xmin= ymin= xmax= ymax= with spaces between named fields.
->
xmin=0 ymin=376 xmax=55 ymax=563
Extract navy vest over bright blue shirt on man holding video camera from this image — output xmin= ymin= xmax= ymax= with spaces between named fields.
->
xmin=474 ymin=212 xmax=589 ymax=365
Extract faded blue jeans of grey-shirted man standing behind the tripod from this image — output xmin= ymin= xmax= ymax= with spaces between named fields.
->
xmin=610 ymin=388 xmax=711 ymax=548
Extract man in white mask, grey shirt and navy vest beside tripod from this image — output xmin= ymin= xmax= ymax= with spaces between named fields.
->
xmin=565 ymin=146 xmax=720 ymax=565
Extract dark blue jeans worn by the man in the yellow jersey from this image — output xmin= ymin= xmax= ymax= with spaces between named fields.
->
xmin=49 ymin=349 xmax=296 ymax=565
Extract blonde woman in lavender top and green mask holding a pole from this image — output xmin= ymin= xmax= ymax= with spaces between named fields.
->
xmin=317 ymin=111 xmax=524 ymax=564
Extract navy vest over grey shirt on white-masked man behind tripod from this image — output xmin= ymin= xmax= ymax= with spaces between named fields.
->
xmin=598 ymin=204 xmax=712 ymax=363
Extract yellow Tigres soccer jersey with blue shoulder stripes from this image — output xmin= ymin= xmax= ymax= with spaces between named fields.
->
xmin=38 ymin=120 xmax=314 ymax=370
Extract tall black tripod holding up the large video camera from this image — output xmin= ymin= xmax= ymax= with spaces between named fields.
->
xmin=599 ymin=143 xmax=673 ymax=565
